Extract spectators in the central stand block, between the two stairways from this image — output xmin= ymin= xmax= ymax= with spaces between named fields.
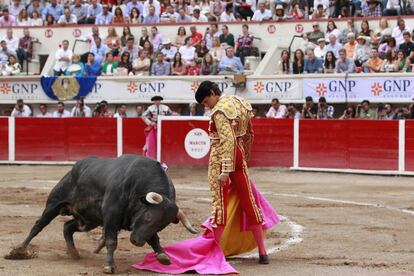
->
xmin=46 ymin=23 xmax=252 ymax=76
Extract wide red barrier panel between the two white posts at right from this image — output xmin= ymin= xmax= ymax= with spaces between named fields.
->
xmin=299 ymin=120 xmax=398 ymax=170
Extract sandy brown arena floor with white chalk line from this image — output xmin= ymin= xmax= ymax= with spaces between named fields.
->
xmin=0 ymin=166 xmax=414 ymax=276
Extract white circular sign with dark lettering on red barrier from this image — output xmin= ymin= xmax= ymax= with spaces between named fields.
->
xmin=184 ymin=128 xmax=210 ymax=159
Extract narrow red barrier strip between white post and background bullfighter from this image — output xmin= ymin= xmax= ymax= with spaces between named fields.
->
xmin=122 ymin=118 xmax=147 ymax=155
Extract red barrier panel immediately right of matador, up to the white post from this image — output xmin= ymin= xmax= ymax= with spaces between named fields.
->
xmin=249 ymin=119 xmax=293 ymax=167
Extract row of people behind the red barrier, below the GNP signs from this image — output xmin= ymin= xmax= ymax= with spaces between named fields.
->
xmin=7 ymin=97 xmax=414 ymax=120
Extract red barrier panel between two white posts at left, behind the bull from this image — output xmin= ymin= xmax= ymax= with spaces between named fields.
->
xmin=15 ymin=118 xmax=117 ymax=161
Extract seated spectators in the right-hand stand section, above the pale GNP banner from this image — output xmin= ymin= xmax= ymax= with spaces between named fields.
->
xmin=276 ymin=18 xmax=414 ymax=74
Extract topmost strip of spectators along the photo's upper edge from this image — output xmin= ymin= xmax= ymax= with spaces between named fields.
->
xmin=0 ymin=0 xmax=414 ymax=27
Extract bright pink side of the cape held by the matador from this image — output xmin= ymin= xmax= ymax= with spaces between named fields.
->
xmin=132 ymin=182 xmax=279 ymax=274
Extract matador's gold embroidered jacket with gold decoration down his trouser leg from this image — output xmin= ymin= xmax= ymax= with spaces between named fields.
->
xmin=208 ymin=95 xmax=253 ymax=223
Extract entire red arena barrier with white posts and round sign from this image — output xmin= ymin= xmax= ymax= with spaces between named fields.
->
xmin=0 ymin=117 xmax=414 ymax=174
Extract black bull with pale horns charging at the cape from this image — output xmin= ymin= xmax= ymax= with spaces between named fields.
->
xmin=6 ymin=155 xmax=197 ymax=273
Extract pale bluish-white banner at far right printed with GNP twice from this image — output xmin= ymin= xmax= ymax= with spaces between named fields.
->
xmin=302 ymin=76 xmax=414 ymax=102
